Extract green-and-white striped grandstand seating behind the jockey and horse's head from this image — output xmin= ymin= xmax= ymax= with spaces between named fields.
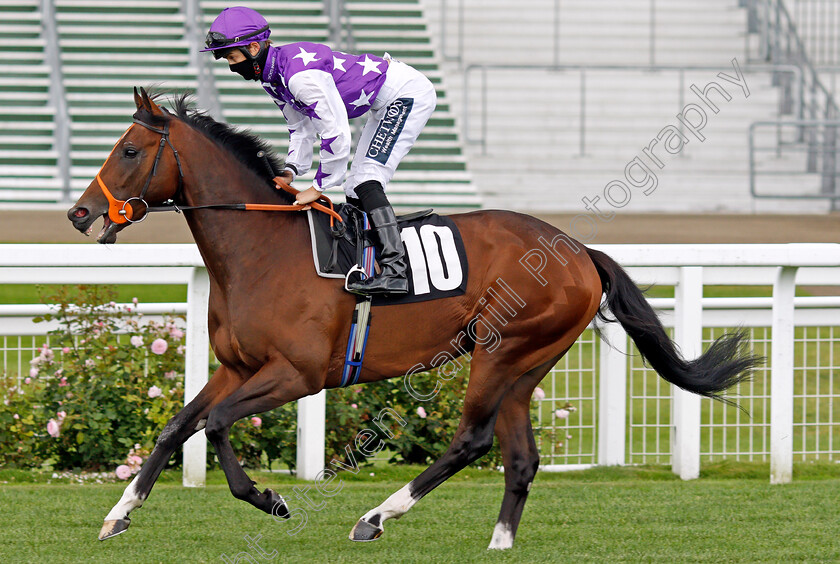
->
xmin=0 ymin=0 xmax=480 ymax=208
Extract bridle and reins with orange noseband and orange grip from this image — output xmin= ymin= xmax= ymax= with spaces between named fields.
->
xmin=96 ymin=119 xmax=344 ymax=227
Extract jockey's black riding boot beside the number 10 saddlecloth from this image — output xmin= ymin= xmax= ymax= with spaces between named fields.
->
xmin=347 ymin=205 xmax=408 ymax=294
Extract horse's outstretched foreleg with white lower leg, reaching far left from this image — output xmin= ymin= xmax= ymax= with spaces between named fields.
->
xmin=99 ymin=367 xmax=239 ymax=540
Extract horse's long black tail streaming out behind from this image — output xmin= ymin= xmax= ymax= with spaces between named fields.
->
xmin=587 ymin=249 xmax=762 ymax=405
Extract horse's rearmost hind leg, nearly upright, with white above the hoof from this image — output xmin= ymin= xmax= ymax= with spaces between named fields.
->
xmin=487 ymin=353 xmax=565 ymax=549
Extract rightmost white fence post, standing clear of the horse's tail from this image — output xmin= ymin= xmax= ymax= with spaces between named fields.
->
xmin=770 ymin=266 xmax=797 ymax=484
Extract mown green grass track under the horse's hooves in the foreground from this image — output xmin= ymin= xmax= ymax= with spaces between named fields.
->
xmin=0 ymin=465 xmax=840 ymax=563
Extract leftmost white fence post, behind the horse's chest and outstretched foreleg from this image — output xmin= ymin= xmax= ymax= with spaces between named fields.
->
xmin=182 ymin=267 xmax=210 ymax=487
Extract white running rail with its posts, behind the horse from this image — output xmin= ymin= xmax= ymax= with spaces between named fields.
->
xmin=0 ymin=243 xmax=840 ymax=485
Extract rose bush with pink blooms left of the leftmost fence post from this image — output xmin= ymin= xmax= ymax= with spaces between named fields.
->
xmin=0 ymin=285 xmax=184 ymax=470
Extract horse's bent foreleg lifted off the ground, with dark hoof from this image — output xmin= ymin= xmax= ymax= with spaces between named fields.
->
xmin=205 ymin=359 xmax=313 ymax=518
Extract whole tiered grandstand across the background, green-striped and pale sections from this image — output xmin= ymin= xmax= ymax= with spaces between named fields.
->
xmin=0 ymin=0 xmax=840 ymax=212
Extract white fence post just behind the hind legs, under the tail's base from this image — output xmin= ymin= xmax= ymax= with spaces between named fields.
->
xmin=598 ymin=323 xmax=627 ymax=466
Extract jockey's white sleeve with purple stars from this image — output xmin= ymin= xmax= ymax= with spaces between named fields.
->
xmin=289 ymin=69 xmax=350 ymax=191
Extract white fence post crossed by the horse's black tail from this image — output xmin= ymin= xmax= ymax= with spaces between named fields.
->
xmin=671 ymin=266 xmax=703 ymax=480
